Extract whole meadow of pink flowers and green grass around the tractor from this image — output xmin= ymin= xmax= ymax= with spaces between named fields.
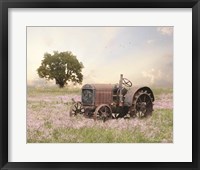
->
xmin=27 ymin=87 xmax=173 ymax=143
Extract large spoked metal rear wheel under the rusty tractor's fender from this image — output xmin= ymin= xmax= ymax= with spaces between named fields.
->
xmin=133 ymin=90 xmax=153 ymax=118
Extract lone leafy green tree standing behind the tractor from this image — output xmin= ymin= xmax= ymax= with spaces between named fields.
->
xmin=37 ymin=51 xmax=83 ymax=88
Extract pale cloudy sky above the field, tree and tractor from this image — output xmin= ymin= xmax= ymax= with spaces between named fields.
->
xmin=27 ymin=26 xmax=173 ymax=87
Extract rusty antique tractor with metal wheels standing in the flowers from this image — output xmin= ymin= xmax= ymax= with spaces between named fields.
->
xmin=70 ymin=74 xmax=154 ymax=121
